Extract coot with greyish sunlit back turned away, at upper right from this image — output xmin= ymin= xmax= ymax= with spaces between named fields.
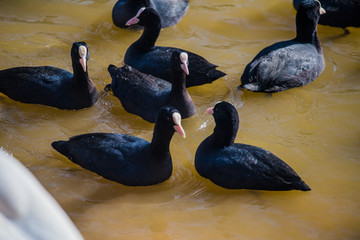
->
xmin=241 ymin=0 xmax=325 ymax=93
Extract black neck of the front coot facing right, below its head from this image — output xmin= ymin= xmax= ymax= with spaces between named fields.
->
xmin=150 ymin=123 xmax=174 ymax=155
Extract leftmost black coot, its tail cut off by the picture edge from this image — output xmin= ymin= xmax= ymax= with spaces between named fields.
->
xmin=0 ymin=42 xmax=98 ymax=109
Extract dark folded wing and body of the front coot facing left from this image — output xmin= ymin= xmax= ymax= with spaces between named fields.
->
xmin=199 ymin=143 xmax=310 ymax=190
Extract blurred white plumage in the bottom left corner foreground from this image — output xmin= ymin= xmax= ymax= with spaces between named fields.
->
xmin=0 ymin=148 xmax=83 ymax=240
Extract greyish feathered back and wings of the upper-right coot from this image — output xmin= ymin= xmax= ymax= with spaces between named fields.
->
xmin=241 ymin=41 xmax=324 ymax=92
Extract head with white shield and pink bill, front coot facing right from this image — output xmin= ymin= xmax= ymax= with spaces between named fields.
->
xmin=155 ymin=106 xmax=186 ymax=138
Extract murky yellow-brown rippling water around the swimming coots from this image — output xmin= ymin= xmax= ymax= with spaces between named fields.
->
xmin=0 ymin=0 xmax=360 ymax=240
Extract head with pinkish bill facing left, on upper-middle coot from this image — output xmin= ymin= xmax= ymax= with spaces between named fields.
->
xmin=125 ymin=7 xmax=161 ymax=27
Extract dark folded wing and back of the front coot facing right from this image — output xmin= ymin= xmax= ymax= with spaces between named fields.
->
xmin=52 ymin=133 xmax=149 ymax=185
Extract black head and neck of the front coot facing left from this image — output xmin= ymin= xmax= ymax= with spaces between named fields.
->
xmin=206 ymin=101 xmax=239 ymax=147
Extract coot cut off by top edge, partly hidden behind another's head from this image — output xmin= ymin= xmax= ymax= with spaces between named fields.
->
xmin=112 ymin=0 xmax=189 ymax=28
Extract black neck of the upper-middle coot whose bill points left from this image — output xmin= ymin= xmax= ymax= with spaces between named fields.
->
xmin=132 ymin=16 xmax=161 ymax=52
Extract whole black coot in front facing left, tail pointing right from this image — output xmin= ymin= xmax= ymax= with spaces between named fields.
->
xmin=195 ymin=102 xmax=311 ymax=191
